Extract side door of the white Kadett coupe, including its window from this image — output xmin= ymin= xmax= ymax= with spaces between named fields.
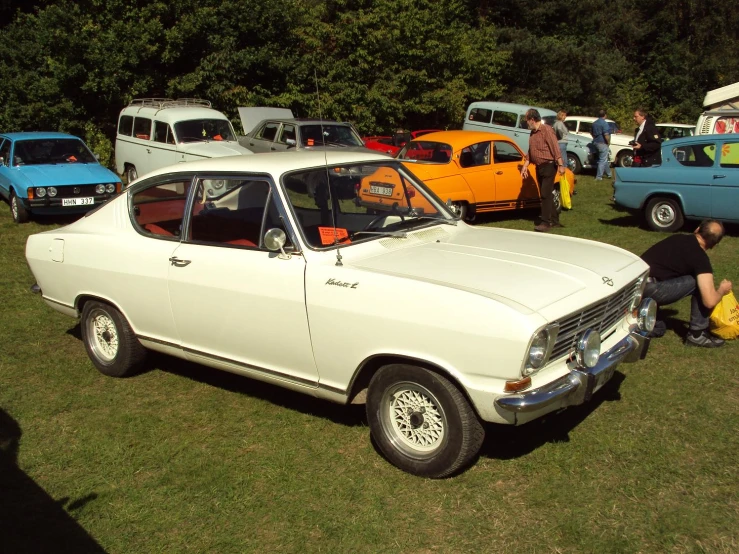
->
xmin=169 ymin=178 xmax=318 ymax=386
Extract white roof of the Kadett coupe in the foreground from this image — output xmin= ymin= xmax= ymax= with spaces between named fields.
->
xmin=139 ymin=148 xmax=395 ymax=177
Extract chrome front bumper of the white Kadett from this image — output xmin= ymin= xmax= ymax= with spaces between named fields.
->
xmin=495 ymin=332 xmax=649 ymax=414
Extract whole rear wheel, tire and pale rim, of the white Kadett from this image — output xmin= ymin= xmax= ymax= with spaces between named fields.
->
xmin=81 ymin=300 xmax=146 ymax=377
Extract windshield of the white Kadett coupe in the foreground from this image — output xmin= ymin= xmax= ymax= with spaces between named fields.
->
xmin=282 ymin=162 xmax=456 ymax=248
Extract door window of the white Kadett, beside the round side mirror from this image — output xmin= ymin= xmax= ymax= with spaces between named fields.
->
xmin=187 ymin=177 xmax=284 ymax=248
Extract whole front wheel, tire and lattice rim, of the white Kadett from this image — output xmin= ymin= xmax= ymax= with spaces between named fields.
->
xmin=367 ymin=364 xmax=485 ymax=478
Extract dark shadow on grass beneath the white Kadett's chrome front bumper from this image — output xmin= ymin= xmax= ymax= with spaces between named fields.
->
xmin=480 ymin=371 xmax=626 ymax=460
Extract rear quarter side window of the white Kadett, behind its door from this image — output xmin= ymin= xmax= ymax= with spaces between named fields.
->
xmin=131 ymin=178 xmax=192 ymax=239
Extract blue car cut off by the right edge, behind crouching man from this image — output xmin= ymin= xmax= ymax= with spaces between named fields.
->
xmin=613 ymin=134 xmax=739 ymax=232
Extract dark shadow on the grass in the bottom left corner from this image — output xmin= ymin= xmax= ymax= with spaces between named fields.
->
xmin=0 ymin=409 xmax=105 ymax=554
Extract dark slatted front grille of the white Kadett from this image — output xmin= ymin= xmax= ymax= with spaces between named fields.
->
xmin=549 ymin=279 xmax=639 ymax=361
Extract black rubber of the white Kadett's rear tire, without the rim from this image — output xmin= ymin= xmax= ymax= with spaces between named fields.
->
xmin=81 ymin=300 xmax=147 ymax=377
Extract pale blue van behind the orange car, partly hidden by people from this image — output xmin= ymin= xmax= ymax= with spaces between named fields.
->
xmin=462 ymin=101 xmax=598 ymax=173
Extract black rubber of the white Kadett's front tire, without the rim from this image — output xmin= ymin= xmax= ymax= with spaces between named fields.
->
xmin=366 ymin=364 xmax=485 ymax=479
